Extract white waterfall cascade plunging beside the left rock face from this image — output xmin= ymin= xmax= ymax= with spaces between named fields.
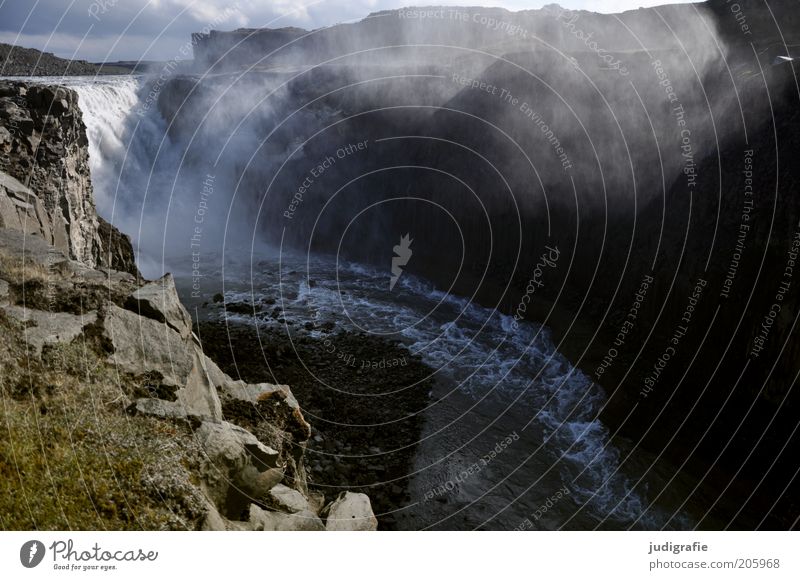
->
xmin=61 ymin=76 xmax=209 ymax=278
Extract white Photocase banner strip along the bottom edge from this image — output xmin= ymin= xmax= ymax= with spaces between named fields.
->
xmin=0 ymin=532 xmax=800 ymax=580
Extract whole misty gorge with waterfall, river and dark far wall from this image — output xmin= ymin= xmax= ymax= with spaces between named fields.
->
xmin=0 ymin=0 xmax=800 ymax=529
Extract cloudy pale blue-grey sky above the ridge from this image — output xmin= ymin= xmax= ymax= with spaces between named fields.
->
xmin=0 ymin=0 xmax=686 ymax=62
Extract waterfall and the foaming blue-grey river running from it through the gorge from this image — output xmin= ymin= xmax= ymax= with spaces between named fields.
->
xmin=21 ymin=77 xmax=712 ymax=529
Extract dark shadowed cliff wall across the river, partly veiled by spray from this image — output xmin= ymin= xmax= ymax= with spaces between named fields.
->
xmin=159 ymin=1 xmax=800 ymax=527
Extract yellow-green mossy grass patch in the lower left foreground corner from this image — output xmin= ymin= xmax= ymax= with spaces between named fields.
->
xmin=0 ymin=324 xmax=209 ymax=530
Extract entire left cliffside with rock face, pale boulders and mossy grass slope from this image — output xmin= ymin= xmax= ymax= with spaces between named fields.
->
xmin=0 ymin=83 xmax=377 ymax=530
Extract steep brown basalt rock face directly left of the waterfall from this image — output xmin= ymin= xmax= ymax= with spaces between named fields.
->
xmin=0 ymin=82 xmax=138 ymax=275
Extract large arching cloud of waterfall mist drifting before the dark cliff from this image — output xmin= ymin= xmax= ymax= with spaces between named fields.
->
xmin=76 ymin=3 xmax=788 ymax=304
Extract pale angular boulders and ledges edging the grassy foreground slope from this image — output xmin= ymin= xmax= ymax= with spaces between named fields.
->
xmin=0 ymin=228 xmax=377 ymax=531
